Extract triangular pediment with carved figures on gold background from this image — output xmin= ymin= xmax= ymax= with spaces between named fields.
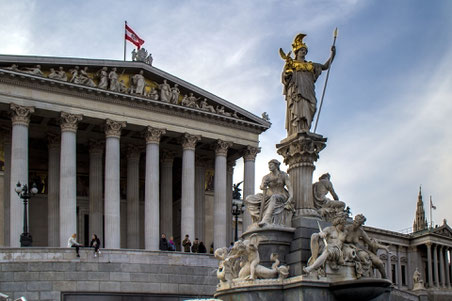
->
xmin=0 ymin=55 xmax=271 ymax=132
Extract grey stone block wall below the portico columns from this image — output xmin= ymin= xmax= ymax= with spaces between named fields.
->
xmin=0 ymin=248 xmax=217 ymax=301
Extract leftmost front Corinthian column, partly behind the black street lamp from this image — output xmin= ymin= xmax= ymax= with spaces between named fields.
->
xmin=10 ymin=103 xmax=35 ymax=248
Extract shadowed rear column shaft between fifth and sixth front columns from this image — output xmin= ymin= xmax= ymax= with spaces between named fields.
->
xmin=195 ymin=158 xmax=206 ymax=241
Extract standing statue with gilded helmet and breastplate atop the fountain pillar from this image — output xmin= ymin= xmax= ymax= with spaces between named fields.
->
xmin=280 ymin=34 xmax=336 ymax=136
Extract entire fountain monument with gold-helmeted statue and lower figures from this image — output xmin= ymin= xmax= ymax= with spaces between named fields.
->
xmin=215 ymin=34 xmax=391 ymax=301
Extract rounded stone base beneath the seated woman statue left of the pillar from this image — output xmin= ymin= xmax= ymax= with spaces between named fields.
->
xmin=241 ymin=224 xmax=295 ymax=268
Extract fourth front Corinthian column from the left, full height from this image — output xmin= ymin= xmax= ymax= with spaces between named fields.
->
xmin=144 ymin=127 xmax=166 ymax=251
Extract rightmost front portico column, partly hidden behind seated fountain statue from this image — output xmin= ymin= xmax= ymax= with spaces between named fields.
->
xmin=242 ymin=146 xmax=261 ymax=232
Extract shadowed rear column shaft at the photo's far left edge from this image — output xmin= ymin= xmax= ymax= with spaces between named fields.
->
xmin=3 ymin=131 xmax=11 ymax=247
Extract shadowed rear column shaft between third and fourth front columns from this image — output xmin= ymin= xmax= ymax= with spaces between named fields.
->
xmin=127 ymin=145 xmax=140 ymax=249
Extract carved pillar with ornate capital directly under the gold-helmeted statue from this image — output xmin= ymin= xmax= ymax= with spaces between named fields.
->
xmin=276 ymin=132 xmax=327 ymax=218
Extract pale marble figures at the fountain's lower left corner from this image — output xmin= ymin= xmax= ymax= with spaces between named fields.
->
xmin=215 ymin=233 xmax=289 ymax=286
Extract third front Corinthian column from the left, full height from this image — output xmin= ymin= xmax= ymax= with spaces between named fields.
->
xmin=105 ymin=119 xmax=127 ymax=249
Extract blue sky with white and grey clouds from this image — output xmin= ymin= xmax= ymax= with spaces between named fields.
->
xmin=0 ymin=0 xmax=452 ymax=231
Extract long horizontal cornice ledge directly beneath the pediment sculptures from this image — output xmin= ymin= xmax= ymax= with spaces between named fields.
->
xmin=0 ymin=69 xmax=270 ymax=134
